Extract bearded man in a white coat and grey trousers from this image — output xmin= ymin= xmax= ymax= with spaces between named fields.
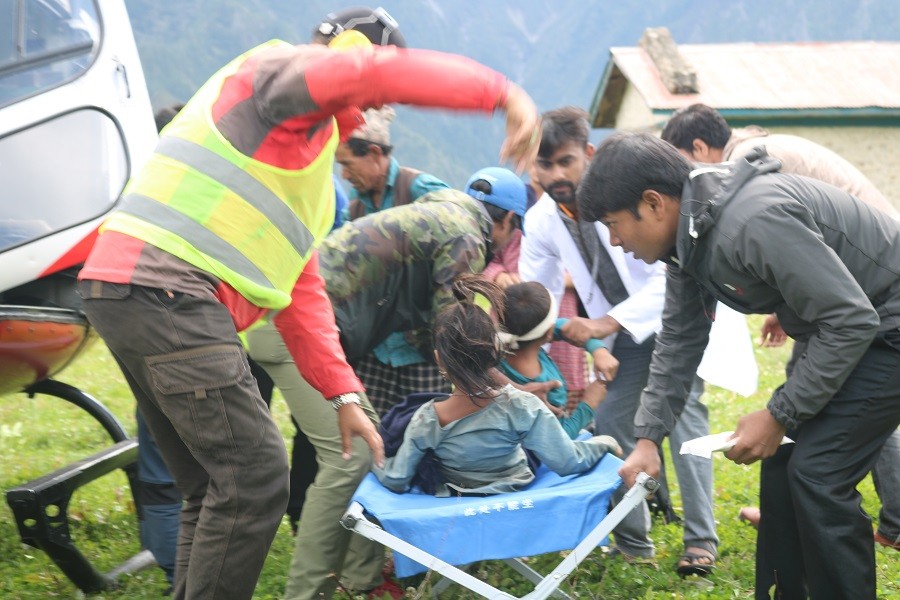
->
xmin=519 ymin=106 xmax=755 ymax=575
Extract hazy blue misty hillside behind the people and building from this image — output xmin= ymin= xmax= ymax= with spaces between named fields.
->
xmin=126 ymin=0 xmax=900 ymax=186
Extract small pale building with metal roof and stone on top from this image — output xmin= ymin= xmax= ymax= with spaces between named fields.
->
xmin=590 ymin=28 xmax=900 ymax=208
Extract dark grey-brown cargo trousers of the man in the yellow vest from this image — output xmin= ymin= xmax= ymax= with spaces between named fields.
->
xmin=79 ymin=281 xmax=288 ymax=599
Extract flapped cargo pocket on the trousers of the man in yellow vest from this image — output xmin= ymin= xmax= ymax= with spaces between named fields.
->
xmin=146 ymin=344 xmax=265 ymax=455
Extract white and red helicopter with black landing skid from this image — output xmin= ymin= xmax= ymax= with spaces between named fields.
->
xmin=0 ymin=0 xmax=157 ymax=593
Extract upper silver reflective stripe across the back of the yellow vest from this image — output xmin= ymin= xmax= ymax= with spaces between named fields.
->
xmin=156 ymin=136 xmax=313 ymax=256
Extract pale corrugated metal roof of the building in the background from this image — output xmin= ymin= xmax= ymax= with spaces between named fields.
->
xmin=593 ymin=42 xmax=900 ymax=126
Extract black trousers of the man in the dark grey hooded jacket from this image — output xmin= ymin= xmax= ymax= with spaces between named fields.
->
xmin=756 ymin=331 xmax=900 ymax=600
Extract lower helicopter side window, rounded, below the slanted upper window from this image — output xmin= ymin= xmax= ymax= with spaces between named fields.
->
xmin=0 ymin=109 xmax=128 ymax=252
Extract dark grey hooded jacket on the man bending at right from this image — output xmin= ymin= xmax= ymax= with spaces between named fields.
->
xmin=635 ymin=148 xmax=900 ymax=443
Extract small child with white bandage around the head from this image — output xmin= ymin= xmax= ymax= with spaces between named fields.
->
xmin=500 ymin=281 xmax=619 ymax=439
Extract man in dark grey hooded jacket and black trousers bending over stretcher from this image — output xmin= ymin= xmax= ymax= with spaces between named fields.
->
xmin=578 ymin=134 xmax=900 ymax=599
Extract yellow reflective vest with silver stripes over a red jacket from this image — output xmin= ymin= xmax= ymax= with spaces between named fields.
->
xmin=101 ymin=41 xmax=338 ymax=309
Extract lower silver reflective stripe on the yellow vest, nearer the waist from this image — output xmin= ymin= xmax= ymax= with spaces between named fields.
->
xmin=118 ymin=194 xmax=275 ymax=289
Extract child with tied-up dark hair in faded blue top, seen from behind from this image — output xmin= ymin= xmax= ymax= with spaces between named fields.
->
xmin=374 ymin=278 xmax=621 ymax=496
